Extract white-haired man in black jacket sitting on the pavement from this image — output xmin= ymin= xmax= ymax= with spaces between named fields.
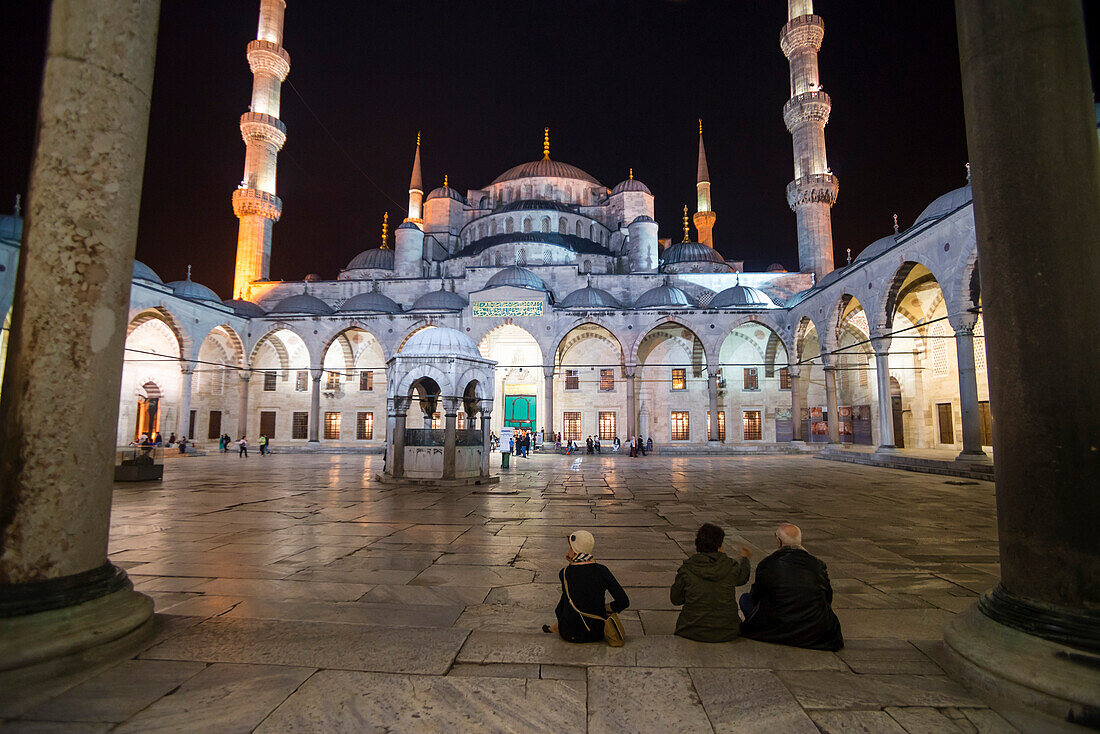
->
xmin=740 ymin=524 xmax=844 ymax=650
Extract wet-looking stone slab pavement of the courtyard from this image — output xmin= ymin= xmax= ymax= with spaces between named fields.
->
xmin=0 ymin=453 xmax=1064 ymax=734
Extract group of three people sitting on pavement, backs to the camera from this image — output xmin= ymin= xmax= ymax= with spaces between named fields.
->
xmin=542 ymin=523 xmax=844 ymax=650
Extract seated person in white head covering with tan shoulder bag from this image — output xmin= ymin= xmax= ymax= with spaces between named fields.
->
xmin=542 ymin=530 xmax=630 ymax=643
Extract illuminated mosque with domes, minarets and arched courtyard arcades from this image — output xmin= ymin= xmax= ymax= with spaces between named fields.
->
xmin=0 ymin=0 xmax=992 ymax=460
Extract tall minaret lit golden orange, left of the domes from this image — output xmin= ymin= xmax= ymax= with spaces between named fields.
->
xmin=233 ymin=0 xmax=290 ymax=299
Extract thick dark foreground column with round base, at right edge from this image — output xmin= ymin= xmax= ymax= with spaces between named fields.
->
xmin=944 ymin=0 xmax=1100 ymax=725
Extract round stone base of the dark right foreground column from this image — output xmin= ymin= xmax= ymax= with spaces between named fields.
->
xmin=944 ymin=605 xmax=1100 ymax=727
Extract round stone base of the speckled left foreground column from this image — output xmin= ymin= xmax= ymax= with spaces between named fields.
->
xmin=0 ymin=581 xmax=153 ymax=670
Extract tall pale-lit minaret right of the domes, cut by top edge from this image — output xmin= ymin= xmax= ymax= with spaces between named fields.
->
xmin=779 ymin=0 xmax=838 ymax=280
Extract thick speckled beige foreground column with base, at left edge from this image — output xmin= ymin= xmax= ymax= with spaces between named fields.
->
xmin=0 ymin=0 xmax=160 ymax=669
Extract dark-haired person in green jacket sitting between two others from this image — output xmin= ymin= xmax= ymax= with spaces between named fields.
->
xmin=669 ymin=523 xmax=752 ymax=643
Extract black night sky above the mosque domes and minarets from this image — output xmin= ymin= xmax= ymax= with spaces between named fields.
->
xmin=0 ymin=0 xmax=1096 ymax=297
